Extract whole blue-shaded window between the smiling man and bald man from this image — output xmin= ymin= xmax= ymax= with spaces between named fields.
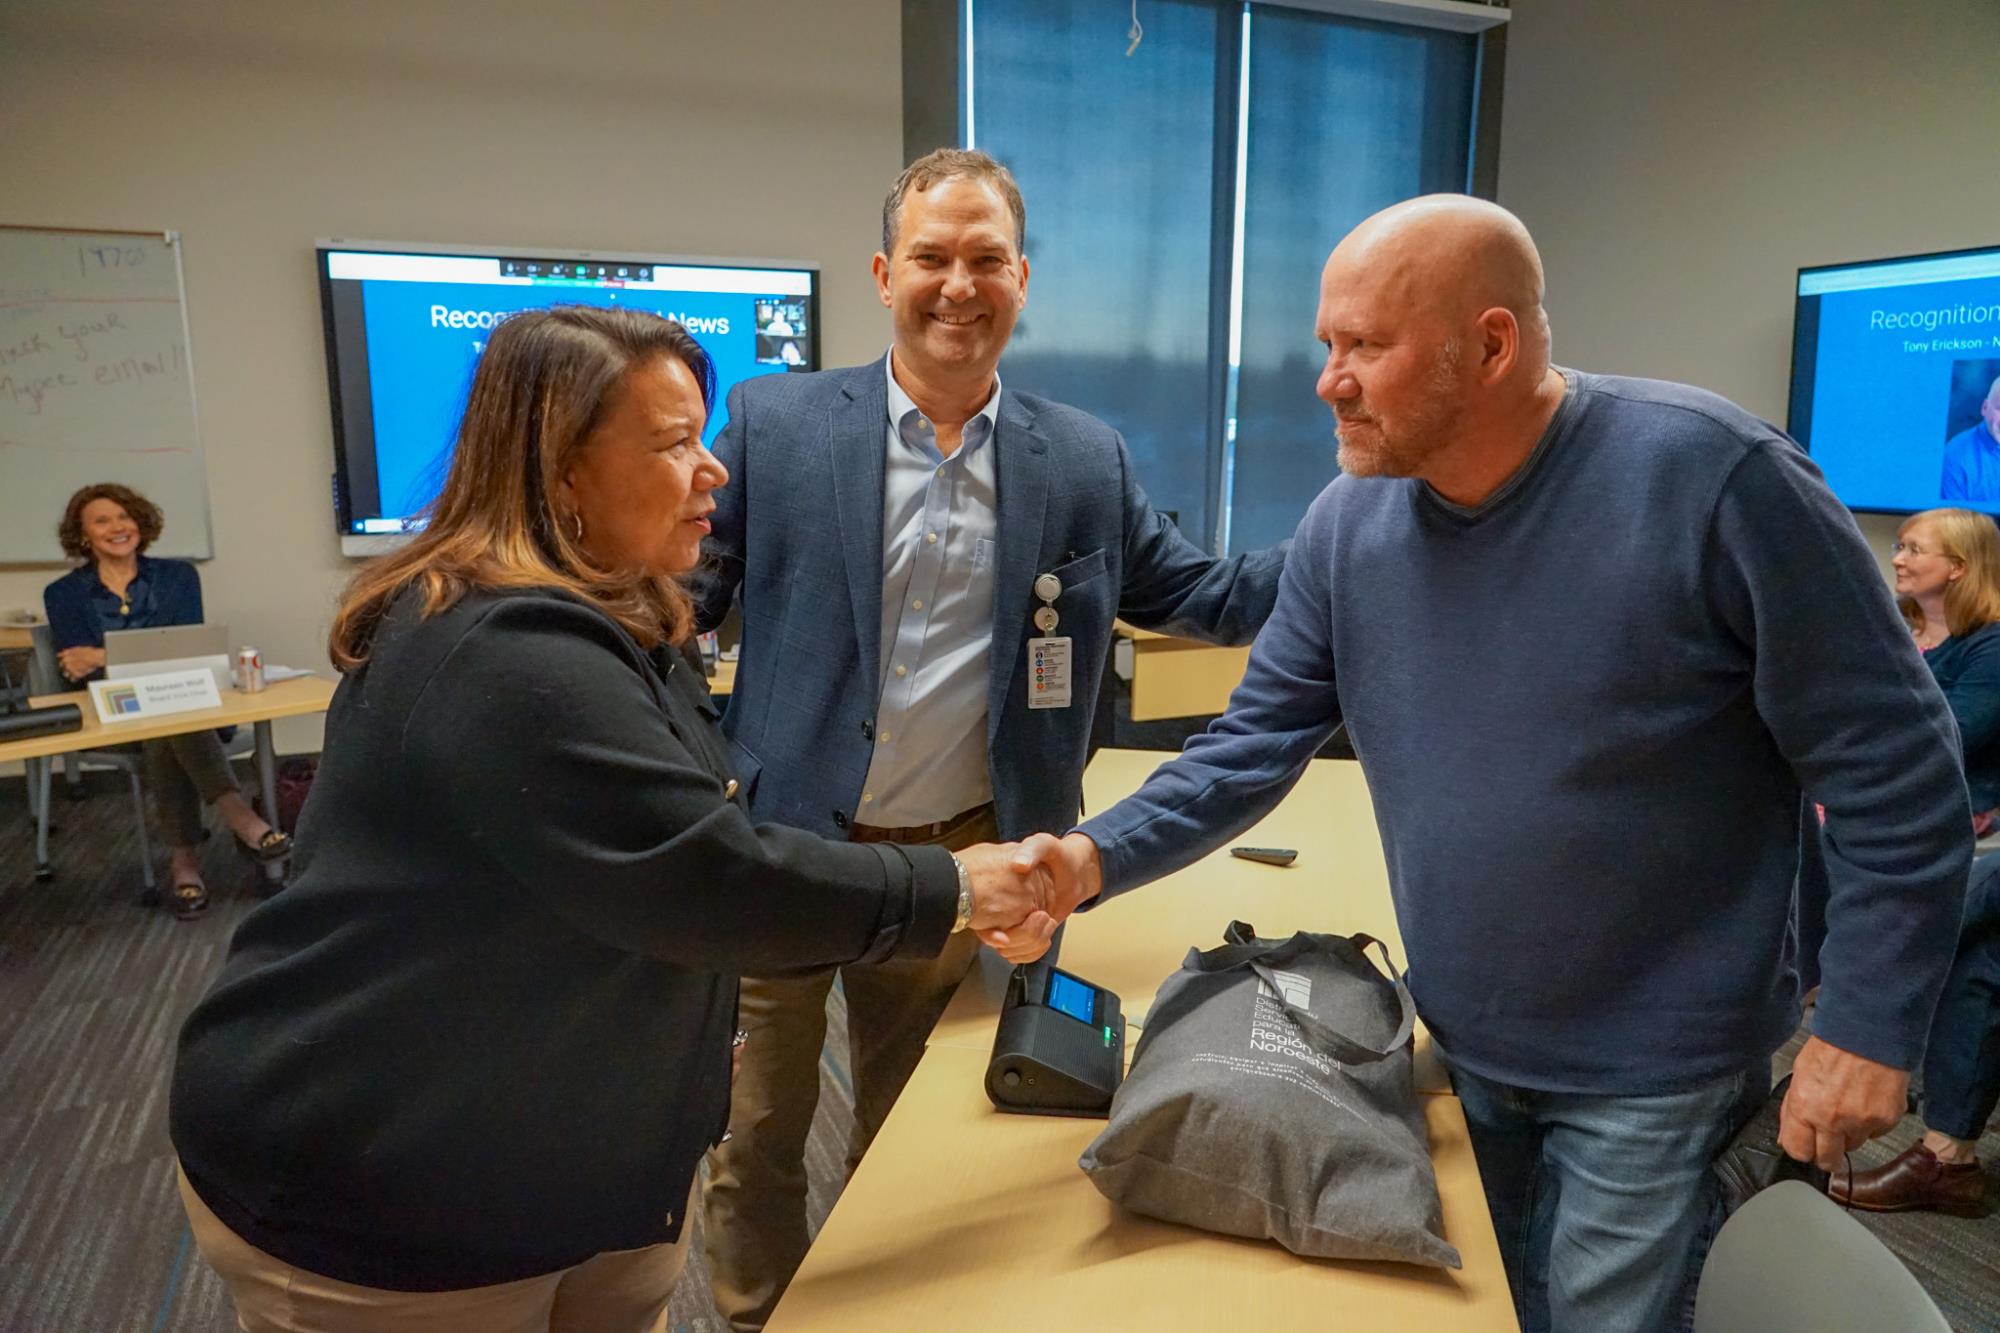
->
xmin=960 ymin=0 xmax=1478 ymax=550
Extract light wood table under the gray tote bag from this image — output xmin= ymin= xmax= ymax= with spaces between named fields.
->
xmin=770 ymin=751 xmax=1516 ymax=1333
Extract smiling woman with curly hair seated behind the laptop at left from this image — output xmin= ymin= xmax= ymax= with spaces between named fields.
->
xmin=42 ymin=482 xmax=292 ymax=921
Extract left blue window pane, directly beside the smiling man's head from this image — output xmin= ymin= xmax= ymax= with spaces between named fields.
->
xmin=972 ymin=0 xmax=1220 ymax=540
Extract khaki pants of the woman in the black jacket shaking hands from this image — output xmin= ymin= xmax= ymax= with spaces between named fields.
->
xmin=176 ymin=1169 xmax=700 ymax=1333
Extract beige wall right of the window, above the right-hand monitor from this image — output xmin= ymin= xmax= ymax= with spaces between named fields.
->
xmin=1500 ymin=0 xmax=2000 ymax=558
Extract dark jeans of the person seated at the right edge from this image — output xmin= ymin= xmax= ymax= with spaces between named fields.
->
xmin=1924 ymin=855 xmax=2000 ymax=1139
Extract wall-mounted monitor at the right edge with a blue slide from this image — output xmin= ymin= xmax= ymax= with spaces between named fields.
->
xmin=1786 ymin=246 xmax=2000 ymax=514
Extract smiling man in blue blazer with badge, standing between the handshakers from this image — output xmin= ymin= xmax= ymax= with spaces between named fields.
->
xmin=696 ymin=148 xmax=1284 ymax=1329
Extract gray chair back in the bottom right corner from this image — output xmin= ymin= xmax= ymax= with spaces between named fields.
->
xmin=1694 ymin=1181 xmax=1952 ymax=1333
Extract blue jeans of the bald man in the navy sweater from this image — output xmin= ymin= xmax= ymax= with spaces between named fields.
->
xmin=1452 ymin=1061 xmax=1770 ymax=1333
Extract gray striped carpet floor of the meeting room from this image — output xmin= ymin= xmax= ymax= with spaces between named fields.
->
xmin=0 ymin=764 xmax=2000 ymax=1333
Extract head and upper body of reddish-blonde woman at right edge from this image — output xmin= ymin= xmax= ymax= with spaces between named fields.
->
xmin=1890 ymin=508 xmax=2000 ymax=833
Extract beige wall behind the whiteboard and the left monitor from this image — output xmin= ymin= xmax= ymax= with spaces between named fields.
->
xmin=0 ymin=0 xmax=902 ymax=751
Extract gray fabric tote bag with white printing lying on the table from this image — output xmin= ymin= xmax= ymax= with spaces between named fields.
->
xmin=1078 ymin=921 xmax=1460 ymax=1269
